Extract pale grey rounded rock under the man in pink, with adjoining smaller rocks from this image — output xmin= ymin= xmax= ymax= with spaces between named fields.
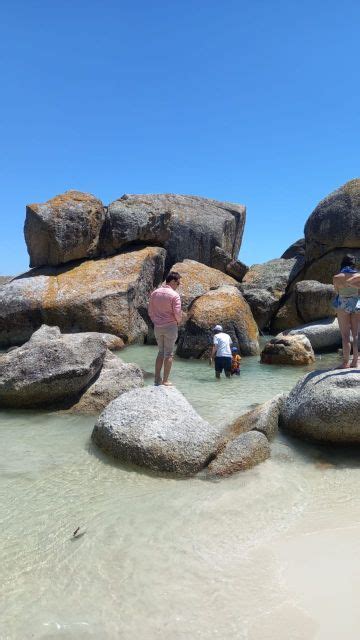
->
xmin=92 ymin=387 xmax=283 ymax=477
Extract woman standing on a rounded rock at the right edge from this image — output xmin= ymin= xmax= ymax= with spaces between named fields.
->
xmin=333 ymin=255 xmax=360 ymax=369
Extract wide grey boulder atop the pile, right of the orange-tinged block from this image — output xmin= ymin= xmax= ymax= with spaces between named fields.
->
xmin=100 ymin=194 xmax=246 ymax=268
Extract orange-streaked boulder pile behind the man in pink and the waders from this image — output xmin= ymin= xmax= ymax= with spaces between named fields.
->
xmin=0 ymin=191 xmax=259 ymax=357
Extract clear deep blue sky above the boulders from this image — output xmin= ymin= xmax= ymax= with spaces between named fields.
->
xmin=0 ymin=0 xmax=360 ymax=275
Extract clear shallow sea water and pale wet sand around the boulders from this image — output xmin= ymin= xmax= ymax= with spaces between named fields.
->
xmin=0 ymin=346 xmax=360 ymax=640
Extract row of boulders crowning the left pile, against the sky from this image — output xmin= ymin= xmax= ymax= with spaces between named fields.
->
xmin=25 ymin=191 xmax=246 ymax=268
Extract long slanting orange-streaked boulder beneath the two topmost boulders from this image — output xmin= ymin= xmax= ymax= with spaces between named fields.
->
xmin=0 ymin=247 xmax=165 ymax=347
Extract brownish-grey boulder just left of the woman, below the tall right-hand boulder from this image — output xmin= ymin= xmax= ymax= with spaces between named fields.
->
xmin=271 ymin=280 xmax=336 ymax=332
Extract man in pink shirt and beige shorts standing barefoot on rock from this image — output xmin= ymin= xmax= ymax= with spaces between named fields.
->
xmin=148 ymin=271 xmax=181 ymax=386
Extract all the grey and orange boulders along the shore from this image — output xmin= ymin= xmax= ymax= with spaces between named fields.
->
xmin=0 ymin=179 xmax=360 ymax=477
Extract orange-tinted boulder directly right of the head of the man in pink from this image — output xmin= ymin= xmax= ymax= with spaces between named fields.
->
xmin=171 ymin=260 xmax=237 ymax=311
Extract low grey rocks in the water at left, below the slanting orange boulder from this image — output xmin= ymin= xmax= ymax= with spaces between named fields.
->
xmin=0 ymin=325 xmax=143 ymax=414
